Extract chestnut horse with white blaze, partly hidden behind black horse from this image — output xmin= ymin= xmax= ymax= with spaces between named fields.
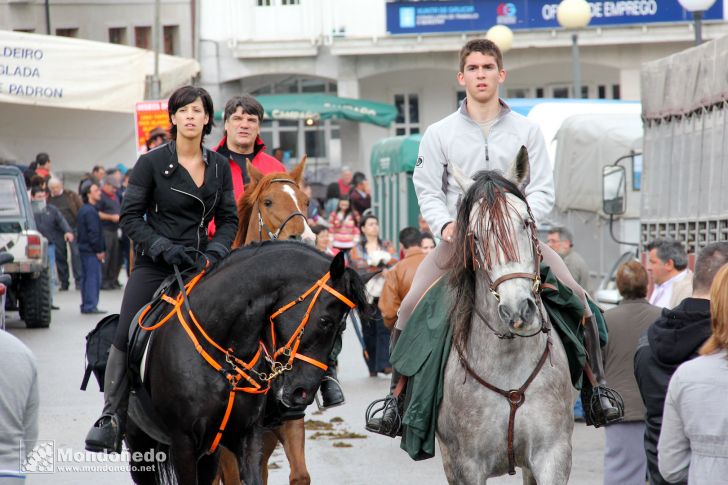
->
xmin=215 ymin=156 xmax=315 ymax=485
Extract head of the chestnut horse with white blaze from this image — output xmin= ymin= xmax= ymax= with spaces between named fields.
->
xmin=234 ymin=156 xmax=316 ymax=247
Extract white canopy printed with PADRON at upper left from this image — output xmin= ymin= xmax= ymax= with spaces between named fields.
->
xmin=0 ymin=31 xmax=200 ymax=113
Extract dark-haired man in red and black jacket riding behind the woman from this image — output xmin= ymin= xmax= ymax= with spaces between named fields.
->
xmin=208 ymin=94 xmax=286 ymax=237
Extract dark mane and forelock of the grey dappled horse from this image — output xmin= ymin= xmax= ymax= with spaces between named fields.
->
xmin=448 ymin=170 xmax=528 ymax=349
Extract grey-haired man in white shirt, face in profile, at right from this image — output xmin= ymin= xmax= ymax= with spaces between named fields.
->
xmin=645 ymin=239 xmax=692 ymax=308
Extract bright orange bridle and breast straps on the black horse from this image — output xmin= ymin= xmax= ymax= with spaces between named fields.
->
xmin=137 ymin=265 xmax=356 ymax=454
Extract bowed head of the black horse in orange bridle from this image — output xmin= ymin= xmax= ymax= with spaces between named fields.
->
xmin=273 ymin=253 xmax=367 ymax=407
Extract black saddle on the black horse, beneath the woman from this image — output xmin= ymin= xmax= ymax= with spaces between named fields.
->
xmin=127 ymin=274 xmax=195 ymax=444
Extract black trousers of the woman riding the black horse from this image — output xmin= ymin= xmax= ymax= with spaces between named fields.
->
xmin=114 ymin=254 xmax=174 ymax=352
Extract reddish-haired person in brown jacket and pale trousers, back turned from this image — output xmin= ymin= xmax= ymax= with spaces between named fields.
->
xmin=604 ymin=261 xmax=661 ymax=485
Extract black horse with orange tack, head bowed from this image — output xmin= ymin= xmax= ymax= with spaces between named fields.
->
xmin=126 ymin=241 xmax=366 ymax=485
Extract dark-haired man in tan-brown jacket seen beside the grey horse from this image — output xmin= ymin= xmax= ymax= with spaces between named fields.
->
xmin=379 ymin=227 xmax=425 ymax=330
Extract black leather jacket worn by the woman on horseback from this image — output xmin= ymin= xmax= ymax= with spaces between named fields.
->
xmin=119 ymin=142 xmax=238 ymax=260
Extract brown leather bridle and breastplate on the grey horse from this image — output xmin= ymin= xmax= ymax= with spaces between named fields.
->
xmin=455 ymin=208 xmax=552 ymax=475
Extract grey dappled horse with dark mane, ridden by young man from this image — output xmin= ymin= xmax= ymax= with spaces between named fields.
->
xmin=437 ymin=148 xmax=574 ymax=485
